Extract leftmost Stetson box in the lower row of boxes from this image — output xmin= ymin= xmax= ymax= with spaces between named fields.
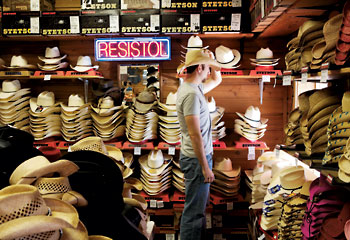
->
xmin=2 ymin=12 xmax=40 ymax=36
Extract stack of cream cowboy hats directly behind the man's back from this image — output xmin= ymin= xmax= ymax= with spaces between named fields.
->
xmin=158 ymin=92 xmax=181 ymax=144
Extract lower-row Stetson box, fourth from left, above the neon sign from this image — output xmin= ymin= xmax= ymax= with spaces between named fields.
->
xmin=120 ymin=10 xmax=160 ymax=34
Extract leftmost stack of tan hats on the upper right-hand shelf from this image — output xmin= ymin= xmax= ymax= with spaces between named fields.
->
xmin=285 ymin=20 xmax=324 ymax=71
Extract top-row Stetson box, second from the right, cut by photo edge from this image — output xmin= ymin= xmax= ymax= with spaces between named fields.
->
xmin=161 ymin=0 xmax=202 ymax=13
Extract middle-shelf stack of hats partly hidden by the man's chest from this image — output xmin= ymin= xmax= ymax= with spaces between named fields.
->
xmin=207 ymin=97 xmax=226 ymax=141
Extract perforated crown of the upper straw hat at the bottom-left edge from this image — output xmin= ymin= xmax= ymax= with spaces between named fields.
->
xmin=0 ymin=184 xmax=49 ymax=224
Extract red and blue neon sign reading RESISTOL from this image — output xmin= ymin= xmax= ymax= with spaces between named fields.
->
xmin=95 ymin=37 xmax=171 ymax=61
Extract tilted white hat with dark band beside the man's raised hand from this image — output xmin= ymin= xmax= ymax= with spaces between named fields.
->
xmin=215 ymin=45 xmax=241 ymax=68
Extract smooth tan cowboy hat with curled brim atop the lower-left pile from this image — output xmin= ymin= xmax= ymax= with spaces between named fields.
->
xmin=10 ymin=156 xmax=78 ymax=184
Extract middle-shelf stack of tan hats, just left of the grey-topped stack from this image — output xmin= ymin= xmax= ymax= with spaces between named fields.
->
xmin=91 ymin=96 xmax=125 ymax=141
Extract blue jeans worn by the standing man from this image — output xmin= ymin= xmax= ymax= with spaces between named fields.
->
xmin=180 ymin=153 xmax=213 ymax=240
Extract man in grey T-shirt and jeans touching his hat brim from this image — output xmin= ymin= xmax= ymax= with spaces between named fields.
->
xmin=176 ymin=49 xmax=222 ymax=240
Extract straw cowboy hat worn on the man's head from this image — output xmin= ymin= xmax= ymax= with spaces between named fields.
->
xmin=177 ymin=50 xmax=220 ymax=73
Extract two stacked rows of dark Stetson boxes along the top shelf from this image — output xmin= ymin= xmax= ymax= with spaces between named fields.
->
xmin=2 ymin=0 xmax=253 ymax=37
